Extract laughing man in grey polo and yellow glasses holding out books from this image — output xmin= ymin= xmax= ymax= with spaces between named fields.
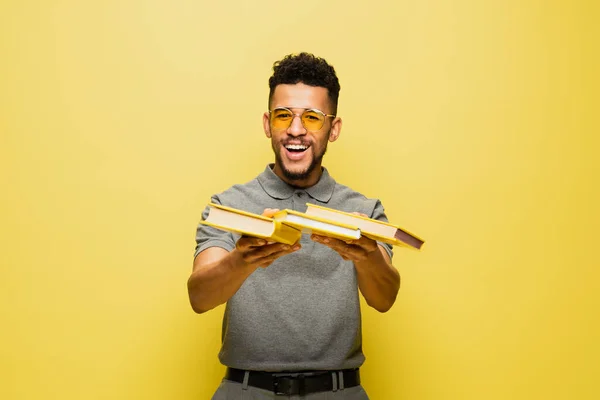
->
xmin=188 ymin=53 xmax=400 ymax=400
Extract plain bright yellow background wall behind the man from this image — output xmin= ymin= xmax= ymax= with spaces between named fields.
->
xmin=0 ymin=0 xmax=600 ymax=400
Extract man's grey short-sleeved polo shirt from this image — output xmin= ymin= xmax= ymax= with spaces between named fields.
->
xmin=194 ymin=164 xmax=392 ymax=371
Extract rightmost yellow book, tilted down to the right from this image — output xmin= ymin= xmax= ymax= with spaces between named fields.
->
xmin=306 ymin=203 xmax=425 ymax=250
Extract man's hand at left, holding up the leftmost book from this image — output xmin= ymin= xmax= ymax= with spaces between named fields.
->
xmin=235 ymin=208 xmax=301 ymax=268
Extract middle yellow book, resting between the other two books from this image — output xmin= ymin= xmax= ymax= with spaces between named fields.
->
xmin=273 ymin=209 xmax=360 ymax=240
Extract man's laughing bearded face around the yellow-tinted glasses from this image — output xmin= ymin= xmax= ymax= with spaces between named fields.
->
xmin=263 ymin=83 xmax=341 ymax=184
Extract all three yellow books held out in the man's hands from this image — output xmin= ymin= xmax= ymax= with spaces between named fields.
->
xmin=200 ymin=203 xmax=425 ymax=250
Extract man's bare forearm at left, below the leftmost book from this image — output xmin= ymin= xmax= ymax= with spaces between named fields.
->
xmin=188 ymin=249 xmax=256 ymax=313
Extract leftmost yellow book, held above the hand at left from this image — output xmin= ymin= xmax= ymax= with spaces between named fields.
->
xmin=200 ymin=203 xmax=302 ymax=245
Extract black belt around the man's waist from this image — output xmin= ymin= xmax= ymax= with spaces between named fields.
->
xmin=225 ymin=368 xmax=360 ymax=396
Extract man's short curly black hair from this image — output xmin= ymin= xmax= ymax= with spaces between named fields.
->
xmin=269 ymin=52 xmax=340 ymax=114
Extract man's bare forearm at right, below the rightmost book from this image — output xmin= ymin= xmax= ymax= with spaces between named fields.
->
xmin=354 ymin=249 xmax=400 ymax=312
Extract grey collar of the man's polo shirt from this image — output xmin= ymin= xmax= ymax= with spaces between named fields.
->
xmin=257 ymin=164 xmax=335 ymax=203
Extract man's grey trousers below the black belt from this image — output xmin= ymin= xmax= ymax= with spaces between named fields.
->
xmin=212 ymin=379 xmax=369 ymax=400
